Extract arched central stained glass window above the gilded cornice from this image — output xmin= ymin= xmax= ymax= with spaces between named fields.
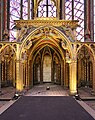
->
xmin=38 ymin=0 xmax=56 ymax=17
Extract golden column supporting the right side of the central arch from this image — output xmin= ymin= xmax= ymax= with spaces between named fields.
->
xmin=69 ymin=61 xmax=77 ymax=95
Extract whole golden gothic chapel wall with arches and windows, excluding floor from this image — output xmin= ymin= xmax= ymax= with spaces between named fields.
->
xmin=0 ymin=0 xmax=95 ymax=94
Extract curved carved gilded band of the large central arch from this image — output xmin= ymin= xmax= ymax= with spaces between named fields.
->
xmin=20 ymin=26 xmax=73 ymax=57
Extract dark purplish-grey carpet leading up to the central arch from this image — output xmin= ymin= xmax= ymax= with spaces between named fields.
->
xmin=0 ymin=96 xmax=94 ymax=120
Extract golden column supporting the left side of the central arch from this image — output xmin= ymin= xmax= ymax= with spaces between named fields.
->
xmin=16 ymin=44 xmax=23 ymax=91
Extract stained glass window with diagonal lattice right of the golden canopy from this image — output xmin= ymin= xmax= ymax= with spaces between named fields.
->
xmin=65 ymin=0 xmax=84 ymax=41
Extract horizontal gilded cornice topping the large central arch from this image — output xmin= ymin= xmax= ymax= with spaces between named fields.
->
xmin=15 ymin=18 xmax=79 ymax=29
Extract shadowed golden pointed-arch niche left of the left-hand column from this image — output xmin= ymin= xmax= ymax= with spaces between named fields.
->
xmin=0 ymin=42 xmax=16 ymax=87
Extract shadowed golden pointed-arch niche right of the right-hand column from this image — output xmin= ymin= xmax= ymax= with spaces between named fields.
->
xmin=77 ymin=43 xmax=95 ymax=87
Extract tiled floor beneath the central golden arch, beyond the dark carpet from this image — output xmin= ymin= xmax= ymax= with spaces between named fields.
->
xmin=26 ymin=83 xmax=68 ymax=96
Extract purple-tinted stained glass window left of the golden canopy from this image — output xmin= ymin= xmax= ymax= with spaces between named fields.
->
xmin=10 ymin=0 xmax=32 ymax=41
